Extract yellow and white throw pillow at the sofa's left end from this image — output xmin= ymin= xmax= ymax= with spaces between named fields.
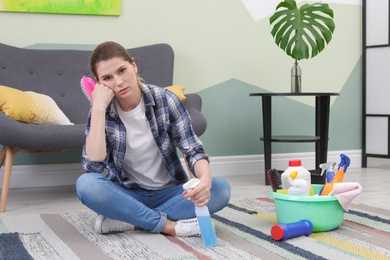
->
xmin=0 ymin=85 xmax=73 ymax=125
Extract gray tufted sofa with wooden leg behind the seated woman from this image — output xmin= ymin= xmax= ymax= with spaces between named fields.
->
xmin=0 ymin=43 xmax=207 ymax=212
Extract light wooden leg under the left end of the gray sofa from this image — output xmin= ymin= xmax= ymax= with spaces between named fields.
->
xmin=0 ymin=146 xmax=14 ymax=212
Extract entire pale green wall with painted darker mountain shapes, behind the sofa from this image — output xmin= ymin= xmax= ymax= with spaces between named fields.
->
xmin=0 ymin=0 xmax=362 ymax=164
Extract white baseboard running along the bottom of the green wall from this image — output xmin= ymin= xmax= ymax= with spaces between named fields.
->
xmin=0 ymin=150 xmax=361 ymax=188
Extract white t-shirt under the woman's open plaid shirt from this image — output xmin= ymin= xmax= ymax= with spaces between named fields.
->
xmin=116 ymin=97 xmax=172 ymax=190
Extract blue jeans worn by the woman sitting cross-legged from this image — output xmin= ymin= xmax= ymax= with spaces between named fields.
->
xmin=76 ymin=173 xmax=230 ymax=233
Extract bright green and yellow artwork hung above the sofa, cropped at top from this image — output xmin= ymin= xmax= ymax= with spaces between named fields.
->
xmin=0 ymin=0 xmax=121 ymax=16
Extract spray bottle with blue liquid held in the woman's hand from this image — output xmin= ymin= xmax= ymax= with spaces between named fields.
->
xmin=183 ymin=178 xmax=218 ymax=247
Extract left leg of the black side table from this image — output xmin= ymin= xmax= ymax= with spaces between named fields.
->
xmin=262 ymin=96 xmax=272 ymax=185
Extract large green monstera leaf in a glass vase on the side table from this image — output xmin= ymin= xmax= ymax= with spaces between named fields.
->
xmin=269 ymin=0 xmax=335 ymax=92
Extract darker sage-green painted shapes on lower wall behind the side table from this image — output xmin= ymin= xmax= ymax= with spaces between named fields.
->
xmin=199 ymin=57 xmax=362 ymax=156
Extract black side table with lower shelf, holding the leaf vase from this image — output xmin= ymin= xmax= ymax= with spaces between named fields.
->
xmin=249 ymin=92 xmax=339 ymax=185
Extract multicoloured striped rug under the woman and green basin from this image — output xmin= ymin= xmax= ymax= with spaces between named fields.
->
xmin=0 ymin=198 xmax=390 ymax=260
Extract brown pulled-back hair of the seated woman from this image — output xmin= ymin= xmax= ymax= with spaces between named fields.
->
xmin=89 ymin=41 xmax=135 ymax=78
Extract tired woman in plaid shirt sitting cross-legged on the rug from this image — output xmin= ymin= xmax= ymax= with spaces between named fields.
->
xmin=76 ymin=42 xmax=230 ymax=236
